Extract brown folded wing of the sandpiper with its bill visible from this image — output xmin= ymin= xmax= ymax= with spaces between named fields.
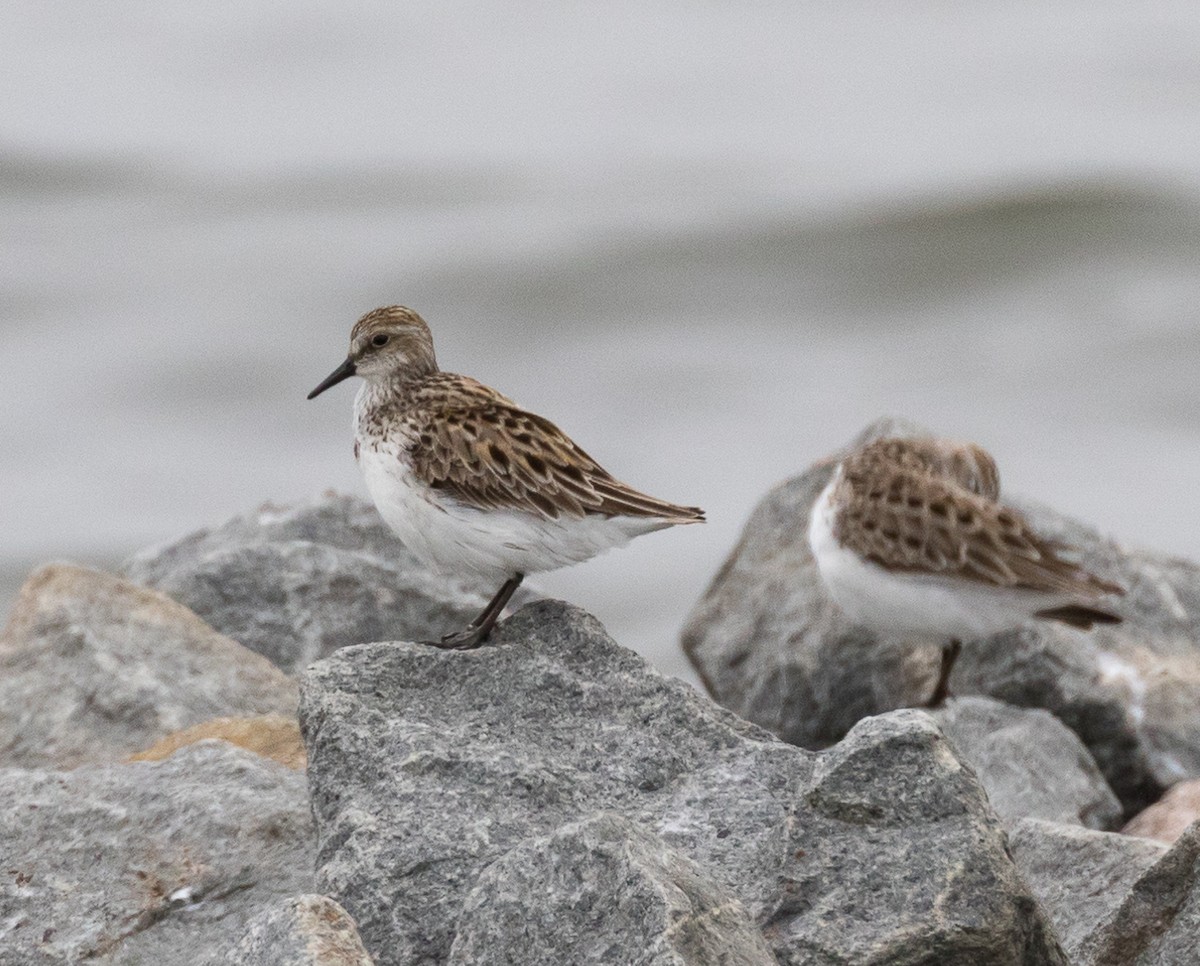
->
xmin=412 ymin=377 xmax=704 ymax=523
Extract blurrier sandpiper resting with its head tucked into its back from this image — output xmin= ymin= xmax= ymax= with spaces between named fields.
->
xmin=809 ymin=439 xmax=1124 ymax=707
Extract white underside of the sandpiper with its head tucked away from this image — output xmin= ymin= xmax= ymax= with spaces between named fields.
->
xmin=809 ymin=469 xmax=1074 ymax=640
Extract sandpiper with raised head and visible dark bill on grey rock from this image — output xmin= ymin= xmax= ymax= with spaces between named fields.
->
xmin=308 ymin=305 xmax=704 ymax=649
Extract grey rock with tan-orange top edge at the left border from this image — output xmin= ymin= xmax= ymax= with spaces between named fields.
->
xmin=0 ymin=564 xmax=296 ymax=768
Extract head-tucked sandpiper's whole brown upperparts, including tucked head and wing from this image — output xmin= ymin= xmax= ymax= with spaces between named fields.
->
xmin=834 ymin=439 xmax=1123 ymax=598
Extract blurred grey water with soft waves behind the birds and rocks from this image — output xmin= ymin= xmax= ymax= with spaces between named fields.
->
xmin=0 ymin=0 xmax=1200 ymax=677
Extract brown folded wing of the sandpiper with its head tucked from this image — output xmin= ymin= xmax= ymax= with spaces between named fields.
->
xmin=835 ymin=457 xmax=1122 ymax=598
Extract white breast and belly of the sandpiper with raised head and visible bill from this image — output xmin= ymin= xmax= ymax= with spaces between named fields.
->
xmin=359 ymin=439 xmax=665 ymax=584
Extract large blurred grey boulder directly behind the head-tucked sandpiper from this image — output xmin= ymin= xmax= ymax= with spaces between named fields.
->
xmin=683 ymin=420 xmax=1200 ymax=812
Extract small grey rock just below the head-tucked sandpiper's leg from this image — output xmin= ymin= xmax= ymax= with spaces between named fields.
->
xmin=931 ymin=697 xmax=1121 ymax=829
